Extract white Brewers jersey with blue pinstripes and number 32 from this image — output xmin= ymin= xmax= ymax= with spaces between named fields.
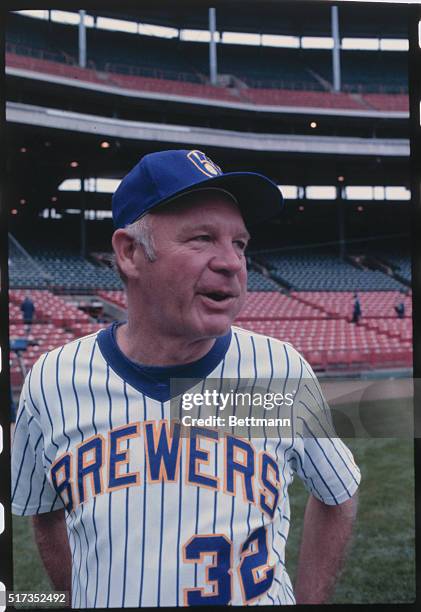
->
xmin=12 ymin=327 xmax=360 ymax=608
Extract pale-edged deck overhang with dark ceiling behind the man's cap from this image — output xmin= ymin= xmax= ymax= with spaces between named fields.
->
xmin=7 ymin=100 xmax=409 ymax=215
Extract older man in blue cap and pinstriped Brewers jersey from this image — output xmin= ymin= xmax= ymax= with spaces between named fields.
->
xmin=12 ymin=151 xmax=360 ymax=607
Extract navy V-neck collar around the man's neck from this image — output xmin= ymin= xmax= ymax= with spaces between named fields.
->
xmin=98 ymin=321 xmax=231 ymax=402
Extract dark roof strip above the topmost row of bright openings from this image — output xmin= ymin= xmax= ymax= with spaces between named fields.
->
xmin=87 ymin=0 xmax=408 ymax=38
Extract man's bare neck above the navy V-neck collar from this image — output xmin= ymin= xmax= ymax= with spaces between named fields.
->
xmin=116 ymin=321 xmax=215 ymax=366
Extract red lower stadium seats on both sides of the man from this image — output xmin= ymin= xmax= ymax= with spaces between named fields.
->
xmin=10 ymin=284 xmax=412 ymax=385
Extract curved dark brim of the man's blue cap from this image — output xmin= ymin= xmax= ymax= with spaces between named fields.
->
xmin=145 ymin=172 xmax=284 ymax=226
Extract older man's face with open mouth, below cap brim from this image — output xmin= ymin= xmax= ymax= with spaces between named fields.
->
xmin=133 ymin=191 xmax=249 ymax=340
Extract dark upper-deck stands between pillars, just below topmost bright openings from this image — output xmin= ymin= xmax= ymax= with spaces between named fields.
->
xmin=6 ymin=9 xmax=407 ymax=102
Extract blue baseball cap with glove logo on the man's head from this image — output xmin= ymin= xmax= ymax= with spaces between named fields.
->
xmin=112 ymin=150 xmax=283 ymax=229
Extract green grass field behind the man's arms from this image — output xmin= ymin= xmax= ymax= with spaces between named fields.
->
xmin=14 ymin=439 xmax=415 ymax=603
